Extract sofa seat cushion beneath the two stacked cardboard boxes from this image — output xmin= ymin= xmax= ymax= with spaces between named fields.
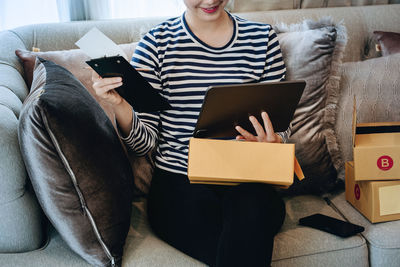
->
xmin=332 ymin=193 xmax=400 ymax=267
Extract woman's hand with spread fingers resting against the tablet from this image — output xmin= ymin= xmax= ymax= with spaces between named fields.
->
xmin=235 ymin=111 xmax=282 ymax=143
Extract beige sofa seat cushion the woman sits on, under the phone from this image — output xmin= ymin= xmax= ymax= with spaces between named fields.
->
xmin=0 ymin=196 xmax=368 ymax=267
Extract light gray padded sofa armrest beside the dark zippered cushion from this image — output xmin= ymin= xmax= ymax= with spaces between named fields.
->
xmin=0 ymin=31 xmax=45 ymax=252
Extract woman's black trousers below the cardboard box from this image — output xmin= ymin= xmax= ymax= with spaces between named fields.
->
xmin=148 ymin=169 xmax=286 ymax=267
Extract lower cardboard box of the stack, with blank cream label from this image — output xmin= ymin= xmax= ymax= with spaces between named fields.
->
xmin=346 ymin=162 xmax=400 ymax=223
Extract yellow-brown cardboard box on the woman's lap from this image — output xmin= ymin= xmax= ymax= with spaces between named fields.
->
xmin=188 ymin=138 xmax=304 ymax=186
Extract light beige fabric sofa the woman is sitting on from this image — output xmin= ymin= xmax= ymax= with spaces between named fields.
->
xmin=0 ymin=4 xmax=400 ymax=266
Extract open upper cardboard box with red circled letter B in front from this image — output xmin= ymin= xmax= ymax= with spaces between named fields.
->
xmin=353 ymin=101 xmax=400 ymax=181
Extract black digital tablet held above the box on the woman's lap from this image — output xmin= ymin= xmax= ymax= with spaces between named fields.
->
xmin=194 ymin=81 xmax=306 ymax=138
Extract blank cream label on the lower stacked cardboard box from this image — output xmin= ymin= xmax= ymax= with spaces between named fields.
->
xmin=379 ymin=185 xmax=400 ymax=216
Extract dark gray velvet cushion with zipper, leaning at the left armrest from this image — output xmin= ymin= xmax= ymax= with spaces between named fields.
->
xmin=19 ymin=57 xmax=133 ymax=266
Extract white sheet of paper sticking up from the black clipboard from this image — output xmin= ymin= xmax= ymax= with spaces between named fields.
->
xmin=75 ymin=28 xmax=127 ymax=59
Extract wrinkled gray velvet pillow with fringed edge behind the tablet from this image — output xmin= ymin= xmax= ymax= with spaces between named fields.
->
xmin=275 ymin=18 xmax=347 ymax=194
